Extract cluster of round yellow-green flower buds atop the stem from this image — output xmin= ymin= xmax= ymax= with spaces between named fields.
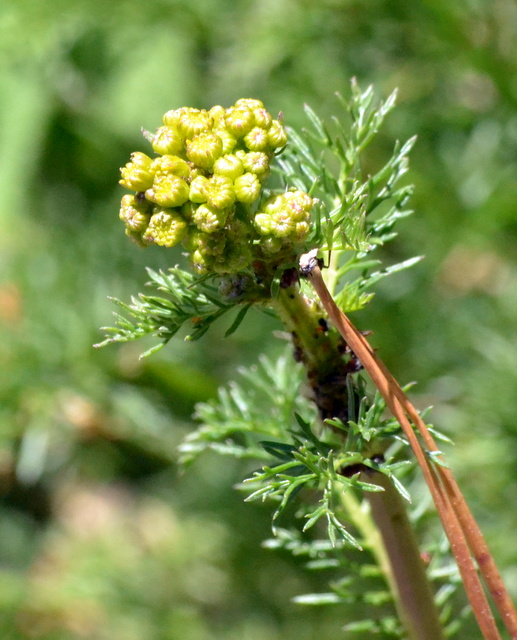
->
xmin=120 ymin=99 xmax=313 ymax=274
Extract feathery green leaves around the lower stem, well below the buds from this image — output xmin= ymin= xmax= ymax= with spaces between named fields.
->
xmin=185 ymin=350 xmax=467 ymax=639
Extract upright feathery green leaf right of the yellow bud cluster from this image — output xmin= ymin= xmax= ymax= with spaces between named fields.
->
xmin=278 ymin=81 xmax=420 ymax=311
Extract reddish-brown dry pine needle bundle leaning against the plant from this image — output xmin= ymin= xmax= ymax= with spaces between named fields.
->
xmin=304 ymin=263 xmax=517 ymax=640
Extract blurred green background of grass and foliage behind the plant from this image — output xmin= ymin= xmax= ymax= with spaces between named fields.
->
xmin=0 ymin=0 xmax=517 ymax=640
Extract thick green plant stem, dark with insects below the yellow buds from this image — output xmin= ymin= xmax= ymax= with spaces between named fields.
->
xmin=274 ymin=285 xmax=443 ymax=640
